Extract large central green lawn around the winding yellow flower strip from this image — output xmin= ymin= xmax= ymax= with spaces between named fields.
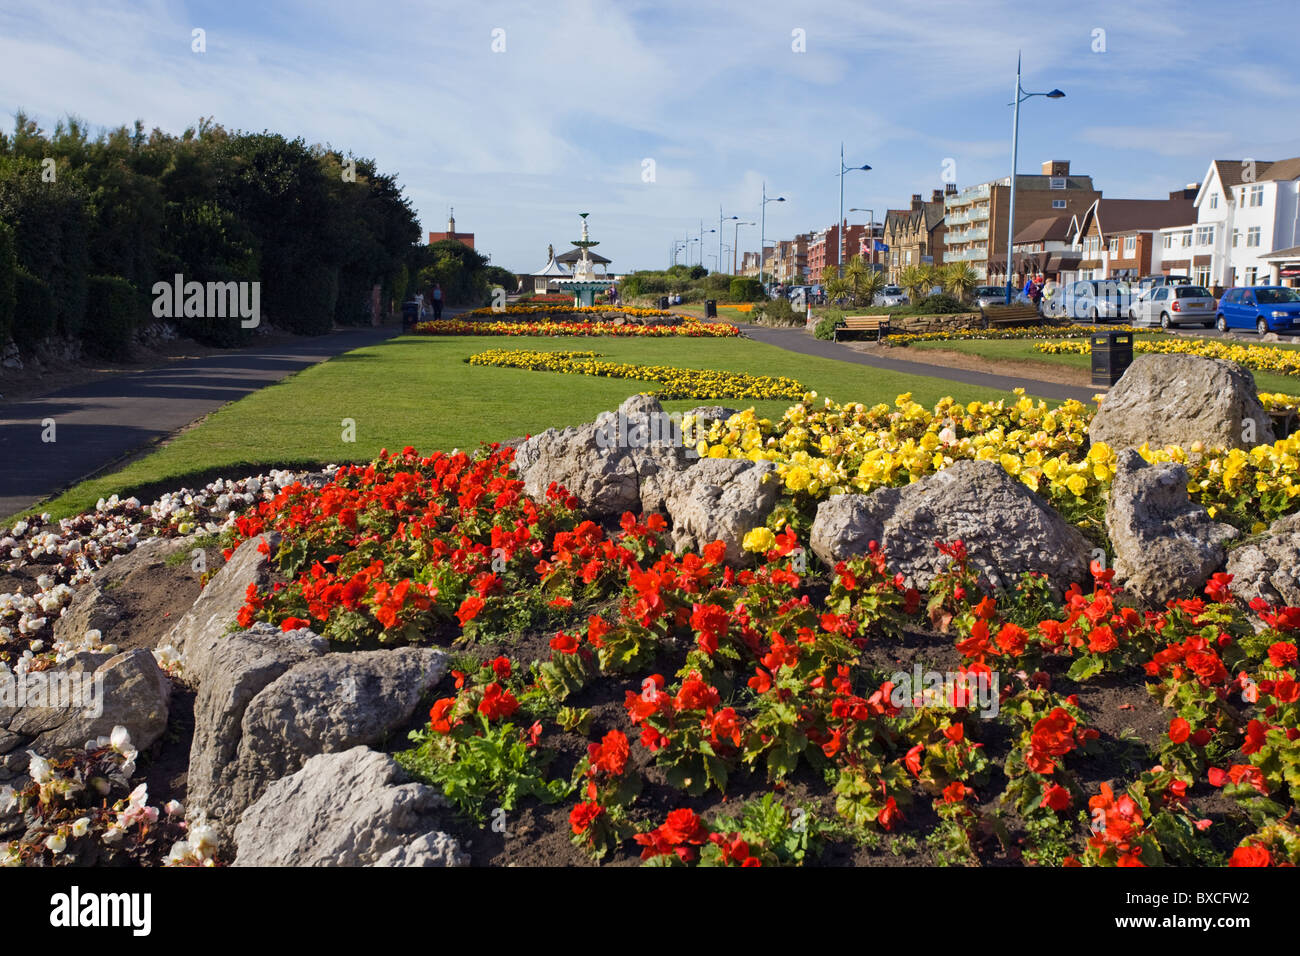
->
xmin=27 ymin=336 xmax=1034 ymax=516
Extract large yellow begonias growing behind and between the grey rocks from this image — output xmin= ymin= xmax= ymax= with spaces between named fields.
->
xmin=698 ymin=393 xmax=1300 ymax=536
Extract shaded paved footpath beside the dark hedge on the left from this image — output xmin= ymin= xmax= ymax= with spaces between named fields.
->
xmin=0 ymin=324 xmax=402 ymax=516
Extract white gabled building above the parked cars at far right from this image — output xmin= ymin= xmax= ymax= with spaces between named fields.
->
xmin=1161 ymin=157 xmax=1300 ymax=289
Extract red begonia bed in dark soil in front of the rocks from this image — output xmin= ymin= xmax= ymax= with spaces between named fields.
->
xmin=208 ymin=449 xmax=1300 ymax=866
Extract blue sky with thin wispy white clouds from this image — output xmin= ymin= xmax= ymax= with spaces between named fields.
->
xmin=0 ymin=0 xmax=1300 ymax=272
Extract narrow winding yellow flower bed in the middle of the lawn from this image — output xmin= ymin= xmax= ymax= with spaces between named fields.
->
xmin=467 ymin=349 xmax=805 ymax=401
